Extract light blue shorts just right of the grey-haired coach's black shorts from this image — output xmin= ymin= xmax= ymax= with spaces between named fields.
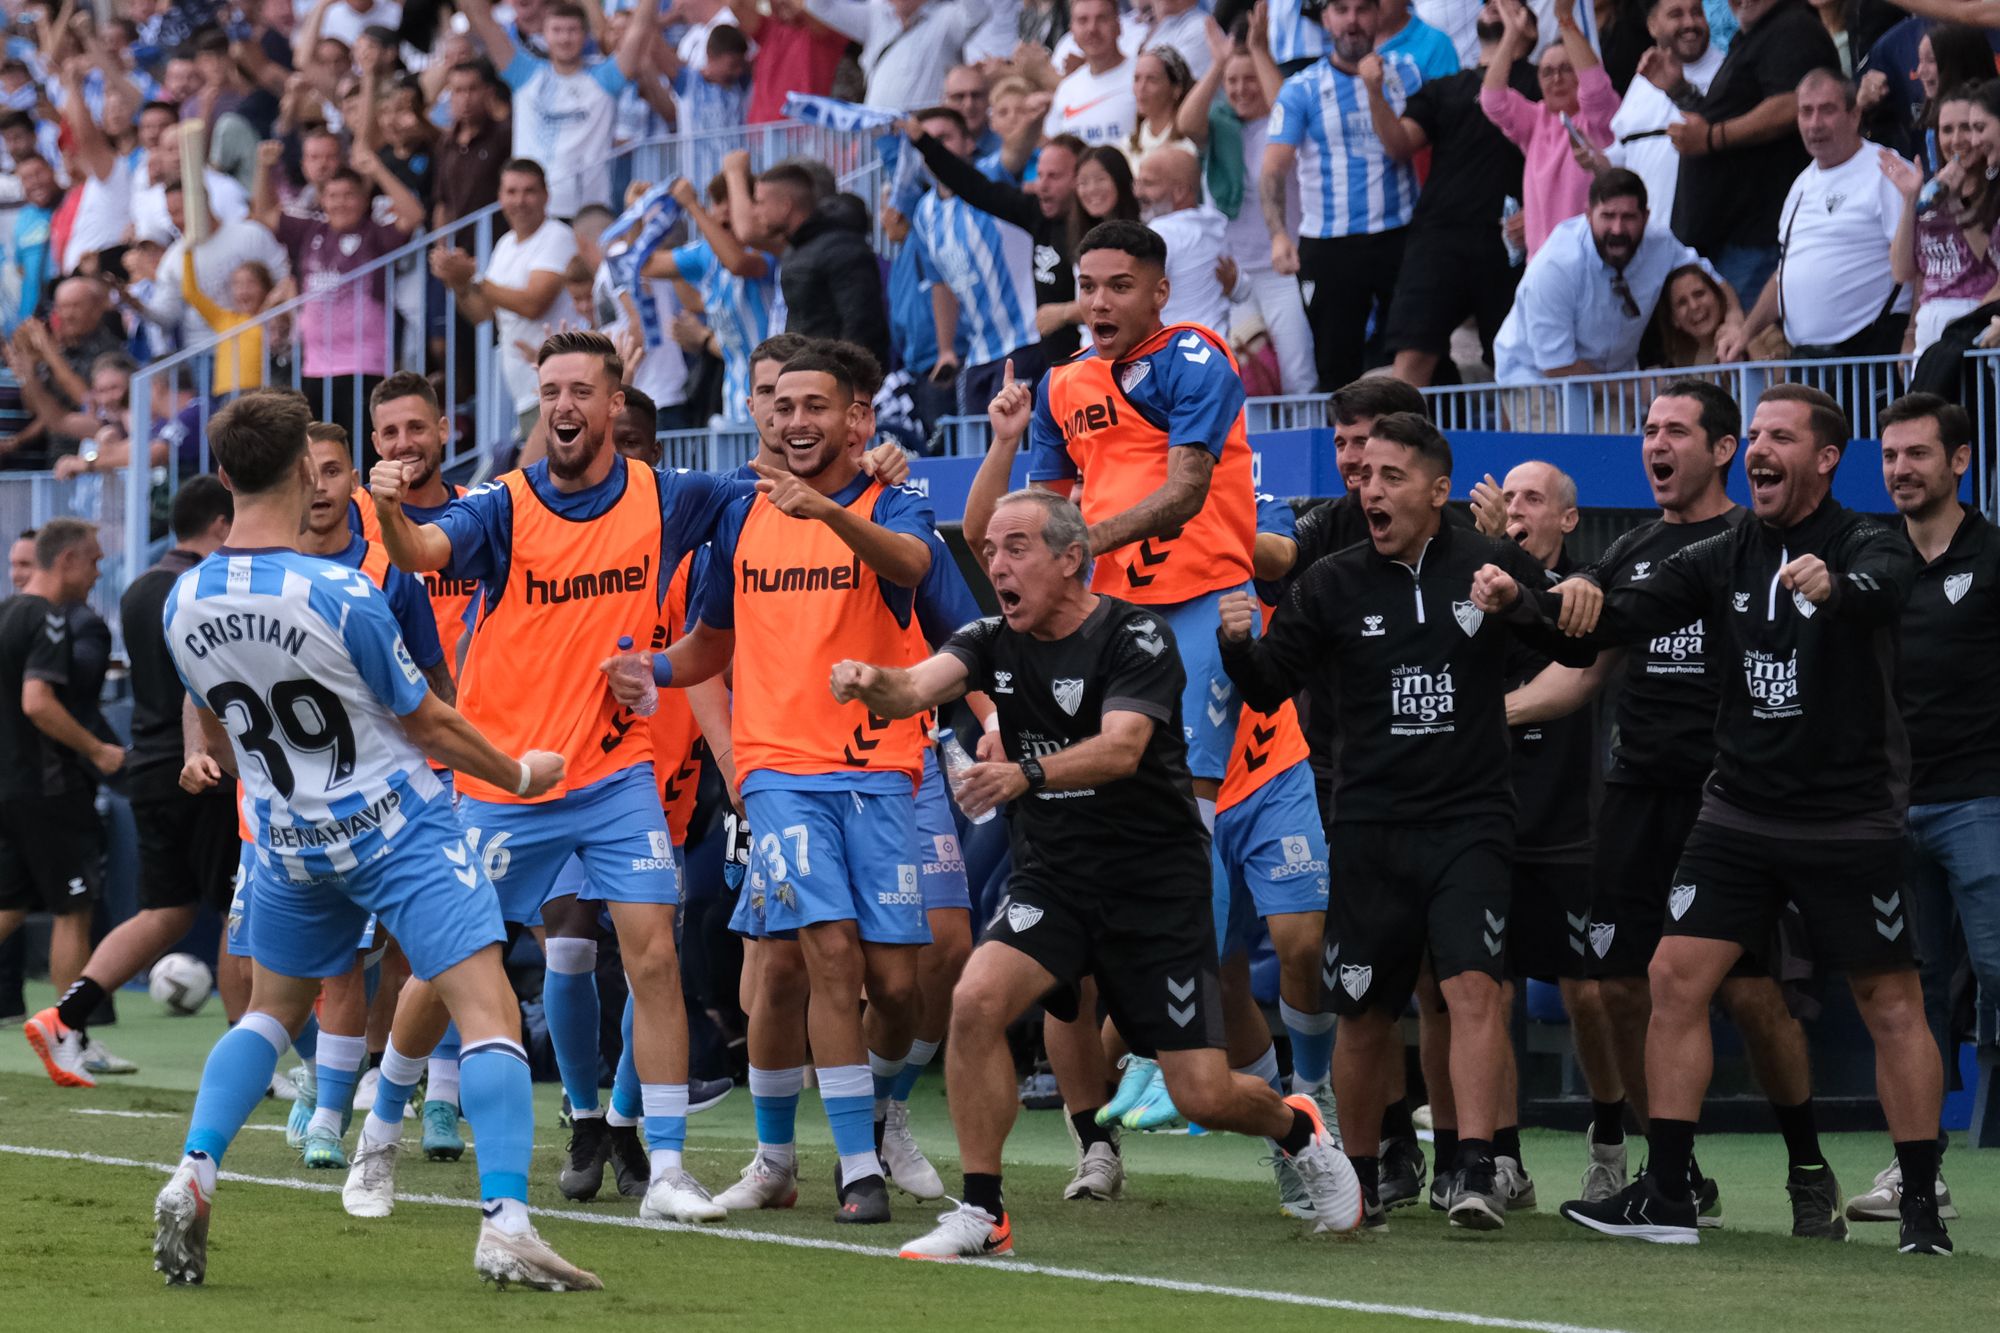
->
xmin=1216 ymin=761 xmax=1332 ymax=959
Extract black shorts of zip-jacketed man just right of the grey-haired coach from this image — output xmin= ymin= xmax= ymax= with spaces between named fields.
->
xmin=1320 ymin=815 xmax=1514 ymax=1015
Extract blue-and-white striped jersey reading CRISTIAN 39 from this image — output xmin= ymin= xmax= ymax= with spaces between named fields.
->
xmin=166 ymin=548 xmax=442 ymax=879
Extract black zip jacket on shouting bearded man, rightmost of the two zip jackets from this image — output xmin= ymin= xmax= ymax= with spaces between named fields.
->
xmin=1522 ymin=496 xmax=1916 ymax=821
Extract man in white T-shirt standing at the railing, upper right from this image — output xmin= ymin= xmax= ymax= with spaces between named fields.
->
xmin=1744 ymin=70 xmax=1910 ymax=360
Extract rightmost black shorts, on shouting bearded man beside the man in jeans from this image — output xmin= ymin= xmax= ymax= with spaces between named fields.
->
xmin=1666 ymin=821 xmax=1916 ymax=973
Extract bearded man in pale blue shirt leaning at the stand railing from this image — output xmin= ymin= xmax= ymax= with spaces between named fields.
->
xmin=1494 ymin=168 xmax=1744 ymax=384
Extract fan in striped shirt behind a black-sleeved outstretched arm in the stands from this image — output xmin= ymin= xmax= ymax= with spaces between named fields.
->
xmin=910 ymin=106 xmax=1048 ymax=416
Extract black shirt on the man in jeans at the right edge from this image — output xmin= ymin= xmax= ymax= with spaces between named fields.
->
xmin=1896 ymin=508 xmax=2000 ymax=805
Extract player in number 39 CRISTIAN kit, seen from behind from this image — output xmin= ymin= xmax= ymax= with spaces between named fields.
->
xmin=154 ymin=390 xmax=602 ymax=1291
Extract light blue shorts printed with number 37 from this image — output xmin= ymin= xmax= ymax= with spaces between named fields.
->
xmin=748 ymin=773 xmax=930 ymax=945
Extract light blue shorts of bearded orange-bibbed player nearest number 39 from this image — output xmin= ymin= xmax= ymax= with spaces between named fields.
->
xmin=454 ymin=763 xmax=680 ymax=929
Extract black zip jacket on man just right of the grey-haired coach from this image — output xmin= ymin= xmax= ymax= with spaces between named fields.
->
xmin=1222 ymin=522 xmax=1596 ymax=823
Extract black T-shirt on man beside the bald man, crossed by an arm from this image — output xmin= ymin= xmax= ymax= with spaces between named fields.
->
xmin=1588 ymin=506 xmax=1750 ymax=787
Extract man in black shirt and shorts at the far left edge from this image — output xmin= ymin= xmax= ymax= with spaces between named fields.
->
xmin=0 ymin=518 xmax=126 ymax=1087
